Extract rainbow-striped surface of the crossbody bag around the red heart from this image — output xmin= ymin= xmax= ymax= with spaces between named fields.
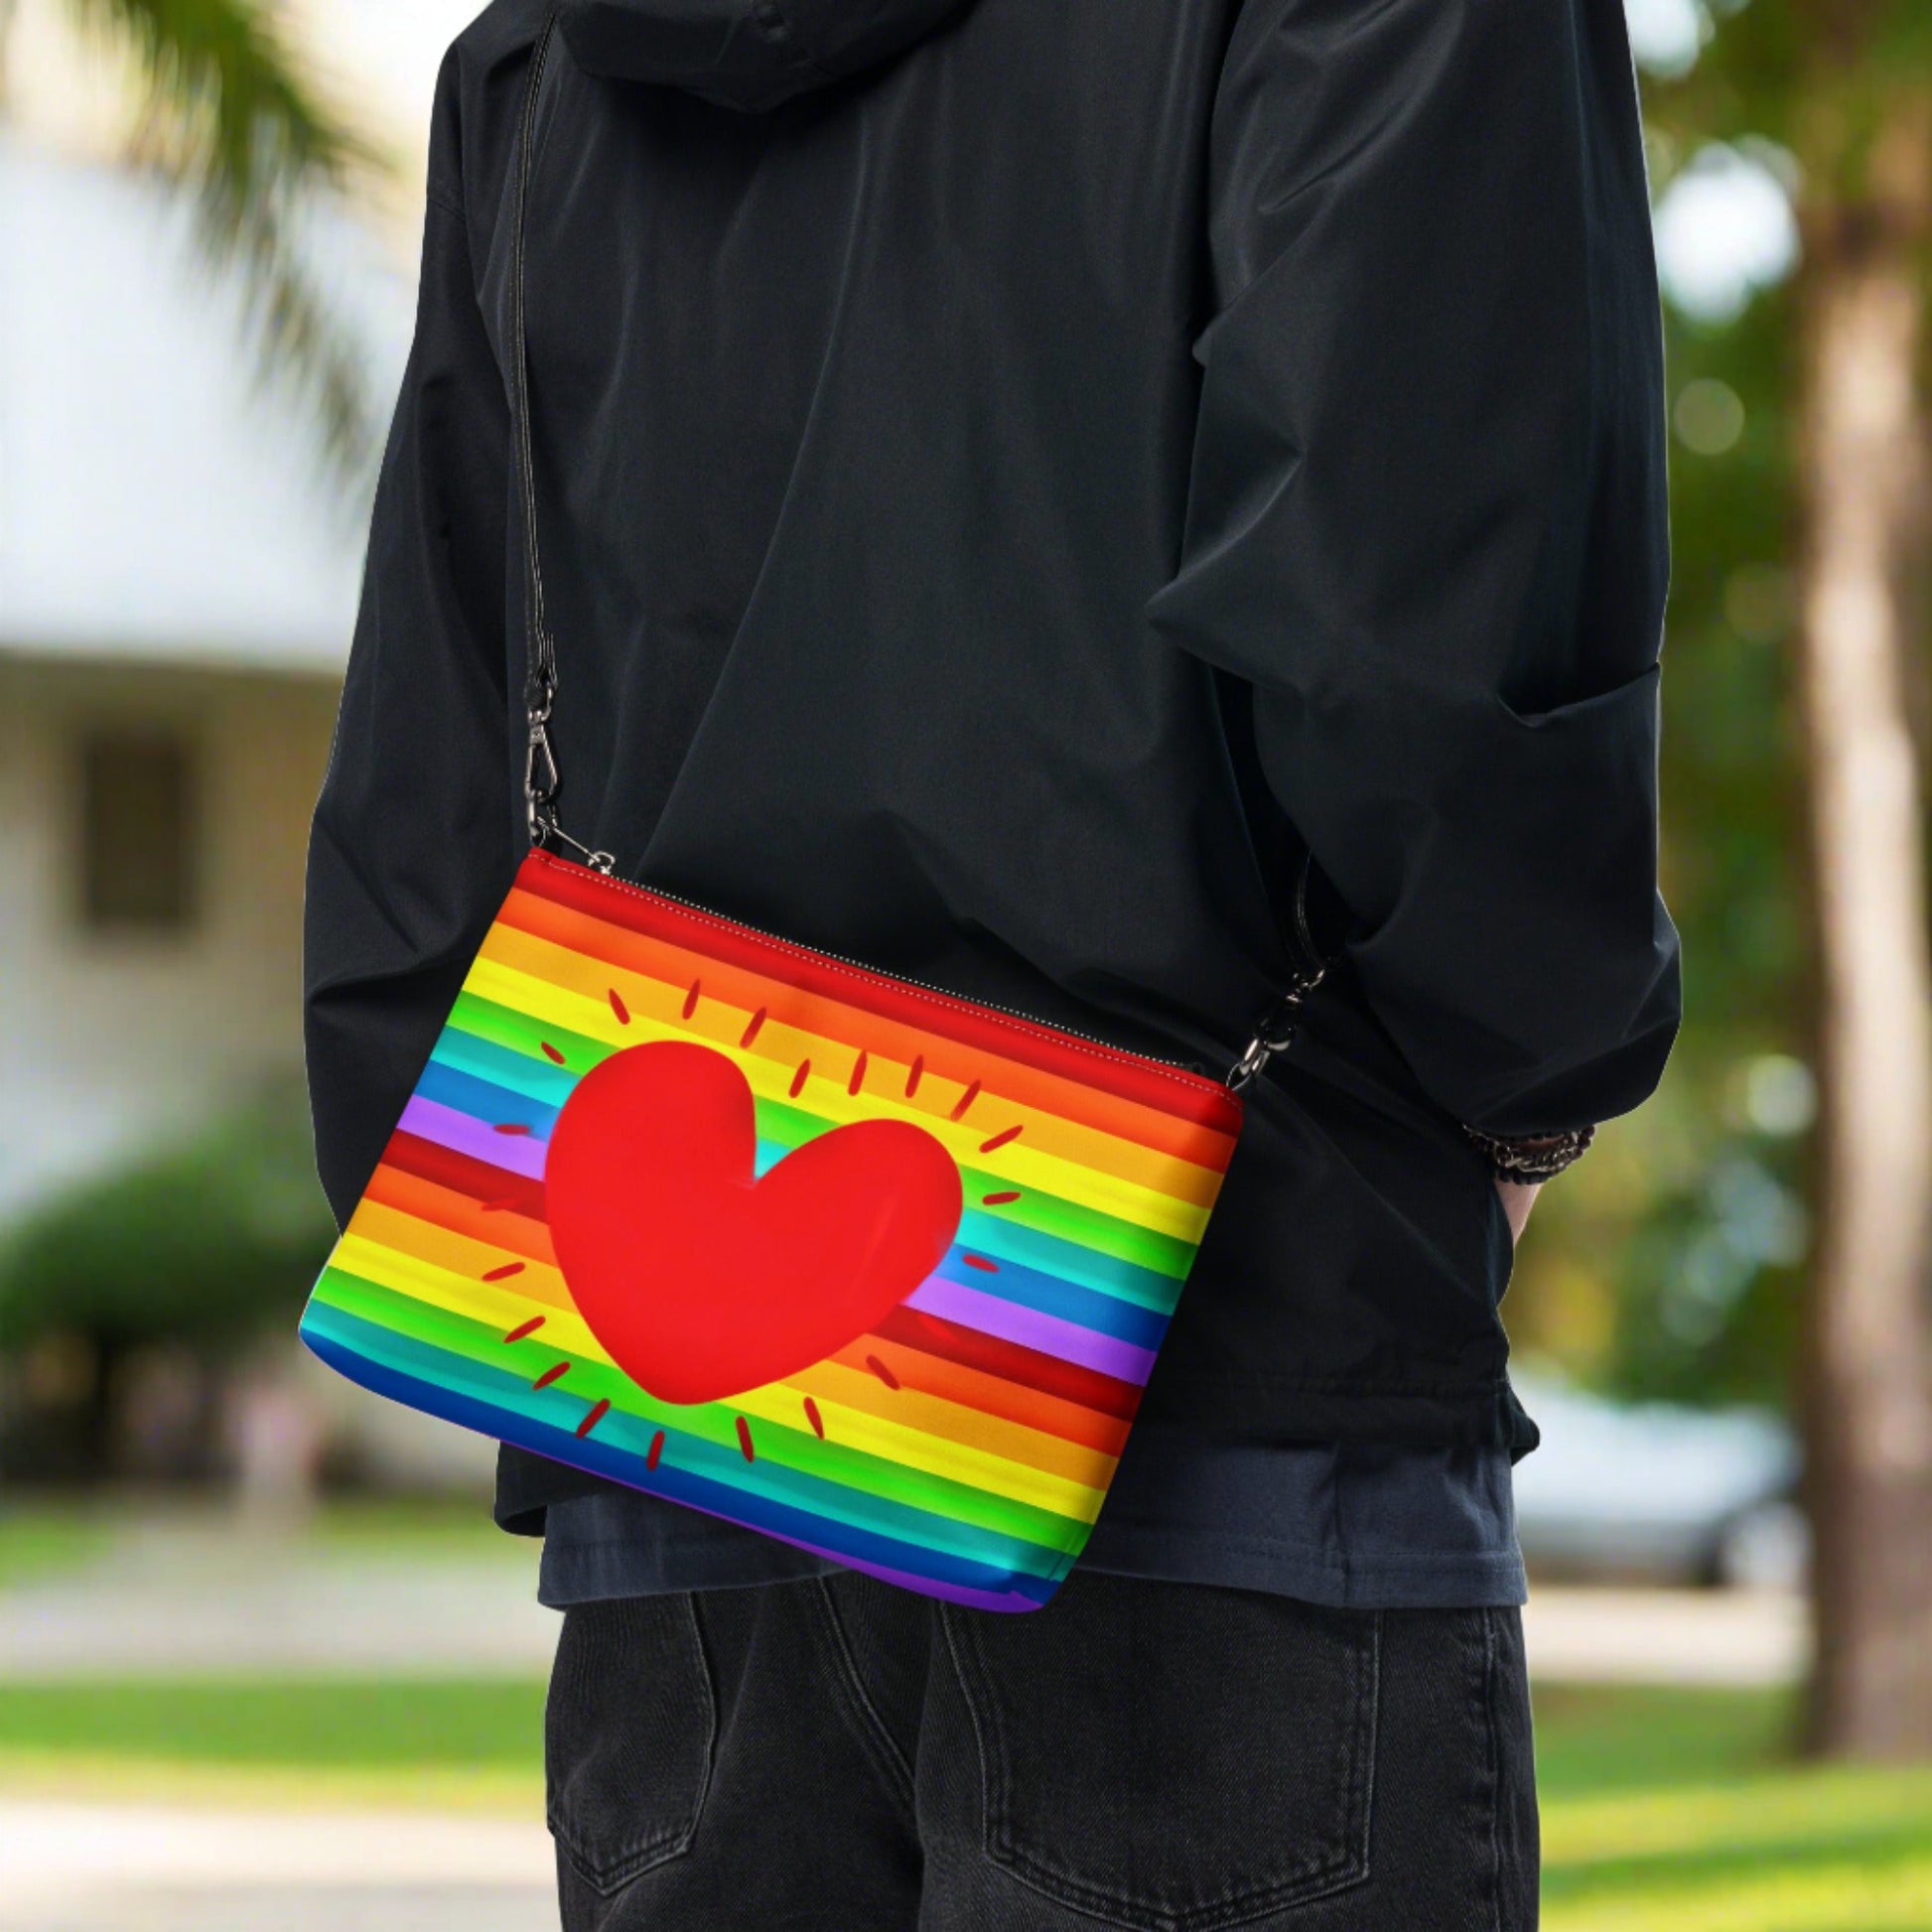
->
xmin=302 ymin=852 xmax=1240 ymax=1609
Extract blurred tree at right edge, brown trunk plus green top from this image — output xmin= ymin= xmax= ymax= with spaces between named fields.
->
xmin=1650 ymin=0 xmax=1932 ymax=1758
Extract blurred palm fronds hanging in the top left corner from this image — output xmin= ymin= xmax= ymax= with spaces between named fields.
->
xmin=12 ymin=0 xmax=382 ymax=482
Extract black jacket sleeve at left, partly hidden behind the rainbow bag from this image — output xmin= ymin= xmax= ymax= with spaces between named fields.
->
xmin=304 ymin=62 xmax=519 ymax=1223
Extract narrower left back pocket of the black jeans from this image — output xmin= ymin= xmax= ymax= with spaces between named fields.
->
xmin=543 ymin=1593 xmax=717 ymax=1893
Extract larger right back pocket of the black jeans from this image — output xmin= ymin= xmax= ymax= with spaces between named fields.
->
xmin=945 ymin=1573 xmax=1381 ymax=1932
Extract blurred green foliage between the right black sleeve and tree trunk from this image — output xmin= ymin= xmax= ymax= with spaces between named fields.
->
xmin=1507 ymin=11 xmax=1824 ymax=1411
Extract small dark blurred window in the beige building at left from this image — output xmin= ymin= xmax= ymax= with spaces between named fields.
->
xmin=81 ymin=731 xmax=196 ymax=931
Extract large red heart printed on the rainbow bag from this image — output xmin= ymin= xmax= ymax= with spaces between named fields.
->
xmin=543 ymin=1039 xmax=960 ymax=1403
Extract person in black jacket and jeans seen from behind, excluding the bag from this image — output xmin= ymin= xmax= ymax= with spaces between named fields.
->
xmin=307 ymin=0 xmax=1679 ymax=1932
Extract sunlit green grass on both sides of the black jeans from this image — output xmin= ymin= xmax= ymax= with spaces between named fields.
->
xmin=0 ymin=1681 xmax=1932 ymax=1932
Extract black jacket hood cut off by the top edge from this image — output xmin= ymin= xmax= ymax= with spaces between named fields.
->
xmin=558 ymin=0 xmax=981 ymax=114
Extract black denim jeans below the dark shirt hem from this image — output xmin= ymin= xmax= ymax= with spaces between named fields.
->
xmin=547 ymin=1575 xmax=1536 ymax=1932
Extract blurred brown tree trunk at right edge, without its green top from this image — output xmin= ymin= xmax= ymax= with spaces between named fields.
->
xmin=1799 ymin=102 xmax=1932 ymax=1758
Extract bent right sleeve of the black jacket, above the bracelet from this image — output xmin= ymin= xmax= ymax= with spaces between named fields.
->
xmin=1150 ymin=0 xmax=1679 ymax=1134
